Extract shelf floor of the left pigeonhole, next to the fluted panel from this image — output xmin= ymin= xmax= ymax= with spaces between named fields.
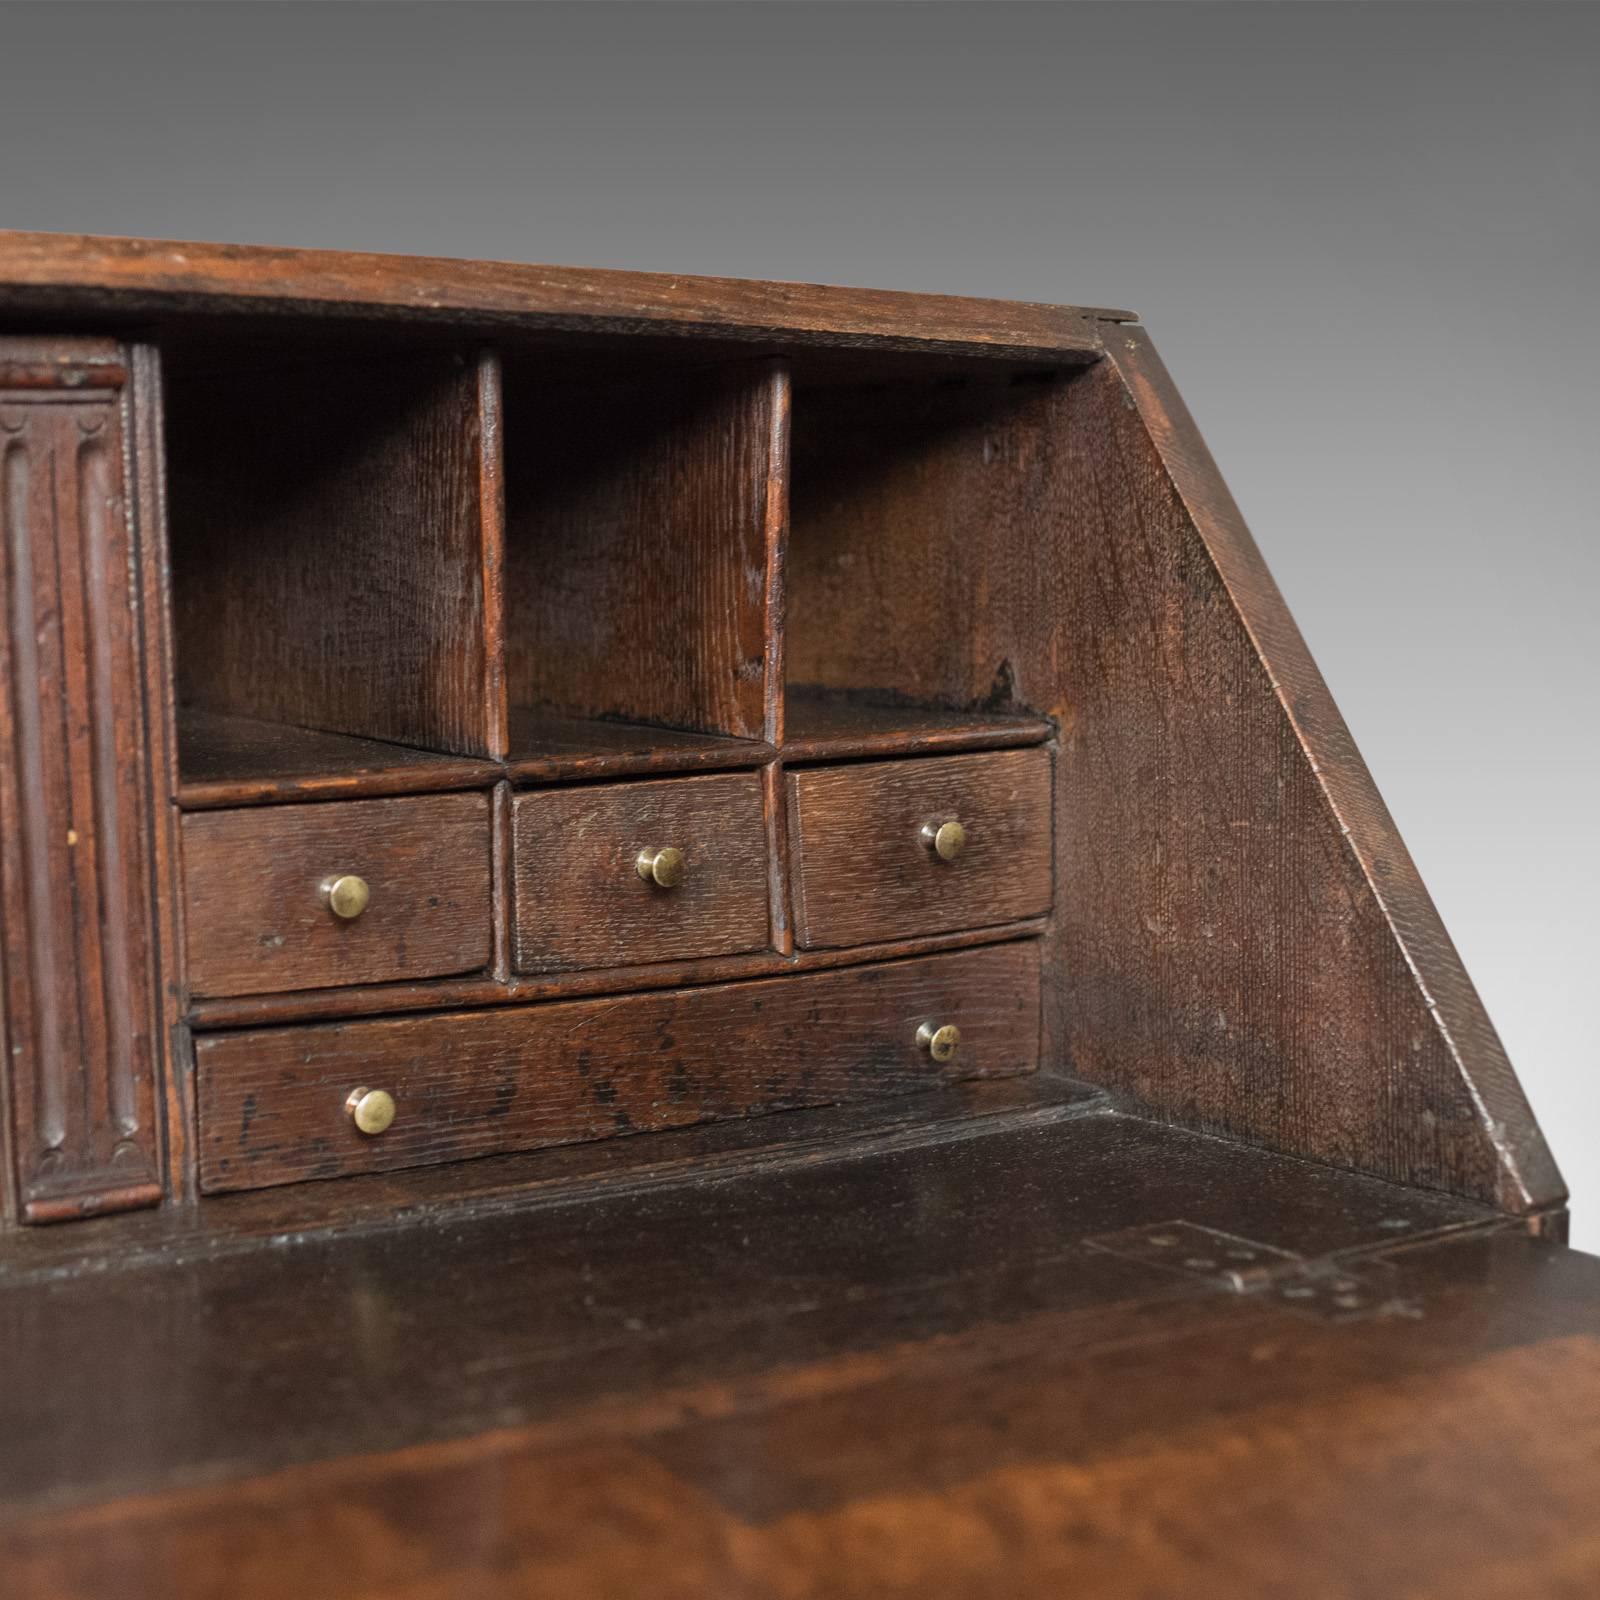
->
xmin=176 ymin=709 xmax=501 ymax=811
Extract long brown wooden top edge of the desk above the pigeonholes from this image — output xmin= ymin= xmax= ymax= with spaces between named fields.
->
xmin=0 ymin=230 xmax=1131 ymax=362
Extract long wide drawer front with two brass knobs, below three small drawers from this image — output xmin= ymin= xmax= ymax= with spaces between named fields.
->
xmin=195 ymin=941 xmax=1038 ymax=1194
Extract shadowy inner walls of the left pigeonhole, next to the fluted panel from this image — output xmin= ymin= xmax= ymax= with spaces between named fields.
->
xmin=166 ymin=347 xmax=506 ymax=755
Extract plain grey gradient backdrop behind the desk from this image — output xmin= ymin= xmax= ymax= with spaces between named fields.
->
xmin=0 ymin=3 xmax=1600 ymax=1248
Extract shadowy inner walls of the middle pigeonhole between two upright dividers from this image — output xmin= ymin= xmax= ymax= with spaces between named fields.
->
xmin=506 ymin=363 xmax=786 ymax=739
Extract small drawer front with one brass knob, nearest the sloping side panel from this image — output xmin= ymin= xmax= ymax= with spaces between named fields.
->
xmin=787 ymin=749 xmax=1053 ymax=949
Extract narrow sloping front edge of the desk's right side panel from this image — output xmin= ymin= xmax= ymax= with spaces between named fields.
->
xmin=1106 ymin=325 xmax=1566 ymax=1214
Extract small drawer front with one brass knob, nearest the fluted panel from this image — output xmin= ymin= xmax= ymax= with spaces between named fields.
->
xmin=182 ymin=794 xmax=491 ymax=995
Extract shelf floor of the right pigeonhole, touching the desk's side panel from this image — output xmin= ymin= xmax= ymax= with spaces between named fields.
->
xmin=782 ymin=688 xmax=1054 ymax=762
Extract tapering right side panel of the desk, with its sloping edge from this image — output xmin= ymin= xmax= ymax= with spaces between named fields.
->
xmin=1051 ymin=340 xmax=1565 ymax=1211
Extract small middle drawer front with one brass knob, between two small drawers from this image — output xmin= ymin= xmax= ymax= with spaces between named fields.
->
xmin=512 ymin=773 xmax=770 ymax=973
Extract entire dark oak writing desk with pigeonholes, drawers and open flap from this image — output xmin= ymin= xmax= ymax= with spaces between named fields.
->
xmin=0 ymin=234 xmax=1600 ymax=1600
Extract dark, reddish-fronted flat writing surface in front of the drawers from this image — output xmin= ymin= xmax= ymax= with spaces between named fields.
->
xmin=12 ymin=1110 xmax=1600 ymax=1600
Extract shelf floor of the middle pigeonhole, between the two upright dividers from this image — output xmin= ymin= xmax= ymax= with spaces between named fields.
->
xmin=506 ymin=707 xmax=774 ymax=782
